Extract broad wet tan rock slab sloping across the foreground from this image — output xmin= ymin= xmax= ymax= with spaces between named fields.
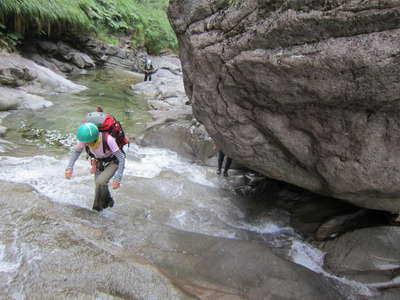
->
xmin=0 ymin=182 xmax=350 ymax=300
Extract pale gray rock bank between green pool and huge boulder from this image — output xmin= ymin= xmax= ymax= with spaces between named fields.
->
xmin=132 ymin=55 xmax=215 ymax=164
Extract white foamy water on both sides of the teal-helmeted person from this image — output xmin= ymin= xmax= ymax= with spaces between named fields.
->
xmin=0 ymin=145 xmax=216 ymax=208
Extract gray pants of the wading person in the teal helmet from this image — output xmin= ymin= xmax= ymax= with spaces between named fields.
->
xmin=93 ymin=161 xmax=118 ymax=211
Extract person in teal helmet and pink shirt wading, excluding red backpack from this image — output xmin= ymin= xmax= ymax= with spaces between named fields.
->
xmin=65 ymin=111 xmax=125 ymax=211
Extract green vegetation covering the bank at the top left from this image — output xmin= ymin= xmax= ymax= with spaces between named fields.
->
xmin=0 ymin=0 xmax=177 ymax=53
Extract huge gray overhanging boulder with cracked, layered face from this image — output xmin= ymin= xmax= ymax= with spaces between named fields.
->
xmin=169 ymin=0 xmax=400 ymax=211
